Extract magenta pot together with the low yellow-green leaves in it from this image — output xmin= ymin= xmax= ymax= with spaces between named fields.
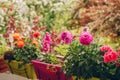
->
xmin=32 ymin=54 xmax=65 ymax=80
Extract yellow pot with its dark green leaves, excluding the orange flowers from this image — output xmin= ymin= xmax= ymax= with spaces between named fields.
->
xmin=5 ymin=45 xmax=38 ymax=79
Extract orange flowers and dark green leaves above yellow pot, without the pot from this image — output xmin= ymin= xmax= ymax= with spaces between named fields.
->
xmin=4 ymin=31 xmax=40 ymax=64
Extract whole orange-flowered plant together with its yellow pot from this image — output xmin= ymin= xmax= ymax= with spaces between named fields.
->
xmin=4 ymin=32 xmax=40 ymax=79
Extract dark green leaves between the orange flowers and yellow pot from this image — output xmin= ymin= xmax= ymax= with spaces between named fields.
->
xmin=13 ymin=45 xmax=39 ymax=64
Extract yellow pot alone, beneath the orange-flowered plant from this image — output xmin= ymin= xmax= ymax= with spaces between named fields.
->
xmin=6 ymin=60 xmax=36 ymax=79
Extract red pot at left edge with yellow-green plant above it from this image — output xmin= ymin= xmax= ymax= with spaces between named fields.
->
xmin=0 ymin=36 xmax=8 ymax=72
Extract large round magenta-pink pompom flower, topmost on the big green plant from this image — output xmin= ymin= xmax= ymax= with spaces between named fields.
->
xmin=79 ymin=32 xmax=93 ymax=45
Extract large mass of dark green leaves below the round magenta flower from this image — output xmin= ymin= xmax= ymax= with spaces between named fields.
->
xmin=64 ymin=41 xmax=120 ymax=80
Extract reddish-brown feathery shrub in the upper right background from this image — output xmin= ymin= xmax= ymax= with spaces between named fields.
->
xmin=70 ymin=0 xmax=120 ymax=49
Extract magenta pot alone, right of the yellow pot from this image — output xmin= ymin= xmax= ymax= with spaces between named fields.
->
xmin=32 ymin=60 xmax=66 ymax=80
